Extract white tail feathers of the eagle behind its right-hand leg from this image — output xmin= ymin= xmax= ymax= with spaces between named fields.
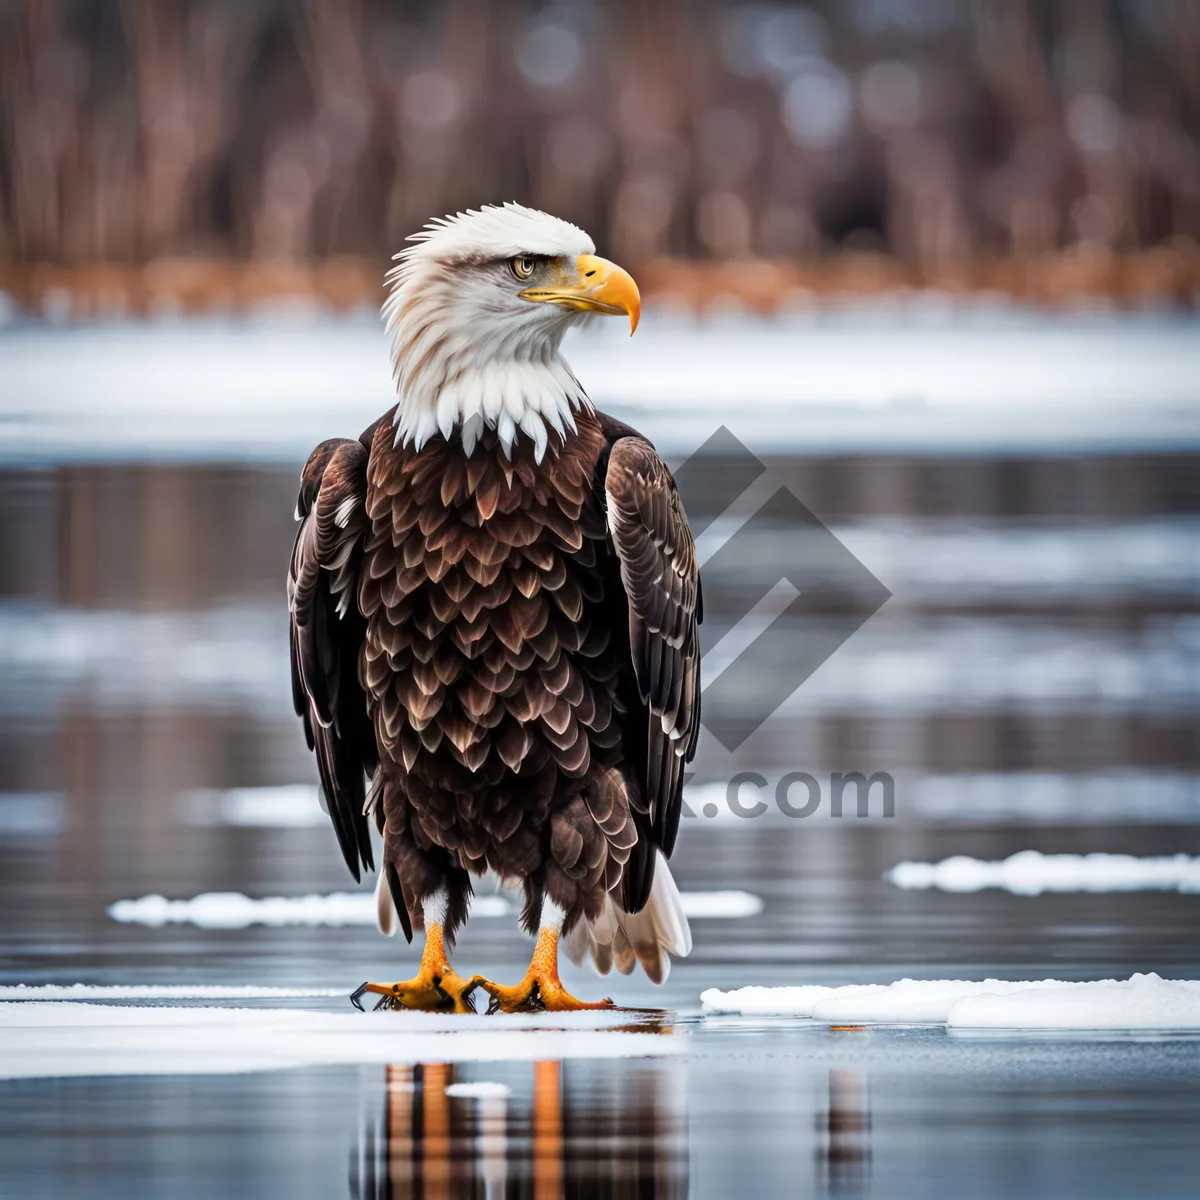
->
xmin=566 ymin=853 xmax=691 ymax=983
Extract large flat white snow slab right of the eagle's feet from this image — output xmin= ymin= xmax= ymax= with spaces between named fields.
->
xmin=701 ymin=973 xmax=1200 ymax=1030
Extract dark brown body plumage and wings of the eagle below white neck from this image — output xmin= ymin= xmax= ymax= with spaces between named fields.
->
xmin=289 ymin=409 xmax=701 ymax=955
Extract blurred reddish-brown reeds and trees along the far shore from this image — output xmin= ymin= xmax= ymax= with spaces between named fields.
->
xmin=0 ymin=0 xmax=1200 ymax=316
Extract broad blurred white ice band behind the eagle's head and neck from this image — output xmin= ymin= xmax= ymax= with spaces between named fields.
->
xmin=0 ymin=306 xmax=1200 ymax=458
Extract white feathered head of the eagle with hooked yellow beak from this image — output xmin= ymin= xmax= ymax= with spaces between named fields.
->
xmin=383 ymin=204 xmax=641 ymax=462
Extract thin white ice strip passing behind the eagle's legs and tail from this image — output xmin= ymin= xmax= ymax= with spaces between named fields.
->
xmin=108 ymin=888 xmax=762 ymax=929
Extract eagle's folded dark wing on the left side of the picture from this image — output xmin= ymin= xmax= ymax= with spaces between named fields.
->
xmin=288 ymin=439 xmax=377 ymax=880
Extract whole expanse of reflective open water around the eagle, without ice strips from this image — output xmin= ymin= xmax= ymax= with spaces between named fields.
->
xmin=0 ymin=321 xmax=1200 ymax=1200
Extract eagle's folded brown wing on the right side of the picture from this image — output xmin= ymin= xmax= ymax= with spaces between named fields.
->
xmin=605 ymin=437 xmax=701 ymax=875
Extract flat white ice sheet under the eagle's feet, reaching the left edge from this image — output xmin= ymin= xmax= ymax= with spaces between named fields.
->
xmin=0 ymin=1002 xmax=684 ymax=1079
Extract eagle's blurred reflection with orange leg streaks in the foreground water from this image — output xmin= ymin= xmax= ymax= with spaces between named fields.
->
xmin=350 ymin=1060 xmax=688 ymax=1200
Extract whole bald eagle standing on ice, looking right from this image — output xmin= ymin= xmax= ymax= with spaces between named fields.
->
xmin=288 ymin=204 xmax=701 ymax=1012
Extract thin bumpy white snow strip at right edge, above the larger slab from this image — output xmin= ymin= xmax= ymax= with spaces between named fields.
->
xmin=884 ymin=850 xmax=1200 ymax=896
